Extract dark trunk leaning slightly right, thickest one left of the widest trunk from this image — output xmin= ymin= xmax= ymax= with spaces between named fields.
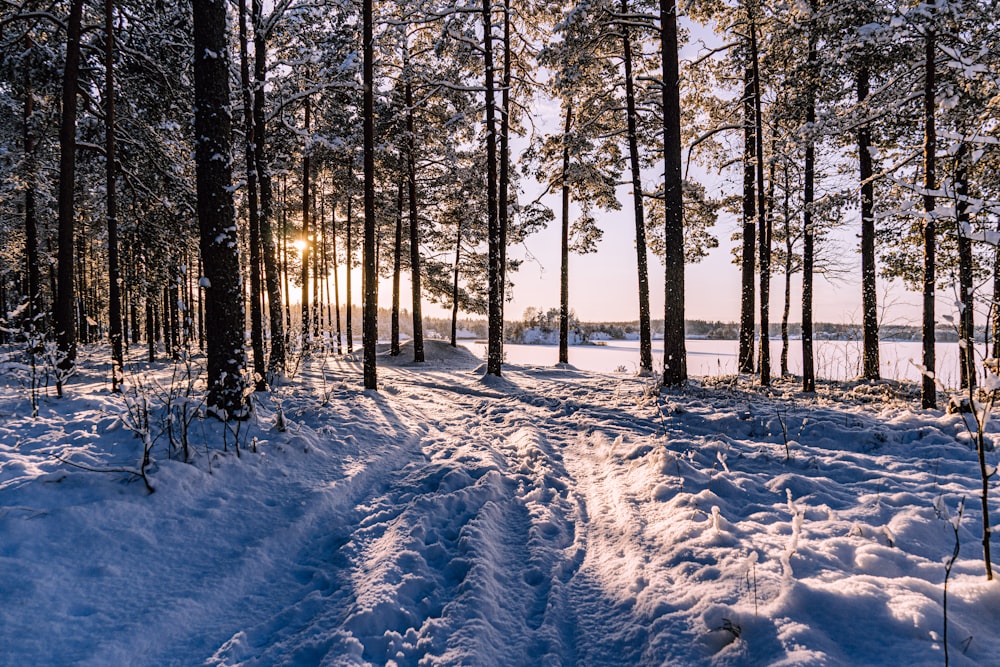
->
xmin=53 ymin=0 xmax=83 ymax=386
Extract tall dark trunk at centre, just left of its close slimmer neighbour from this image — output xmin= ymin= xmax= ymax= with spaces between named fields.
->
xmin=483 ymin=0 xmax=506 ymax=377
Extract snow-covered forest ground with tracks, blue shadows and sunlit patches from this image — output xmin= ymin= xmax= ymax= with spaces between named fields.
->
xmin=0 ymin=342 xmax=1000 ymax=666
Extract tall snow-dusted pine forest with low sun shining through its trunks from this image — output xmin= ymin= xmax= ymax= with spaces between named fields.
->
xmin=0 ymin=0 xmax=1000 ymax=418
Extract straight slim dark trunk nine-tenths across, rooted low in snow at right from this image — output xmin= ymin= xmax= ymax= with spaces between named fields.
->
xmin=920 ymin=29 xmax=937 ymax=409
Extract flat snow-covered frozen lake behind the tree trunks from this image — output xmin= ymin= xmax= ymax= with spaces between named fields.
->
xmin=463 ymin=339 xmax=968 ymax=387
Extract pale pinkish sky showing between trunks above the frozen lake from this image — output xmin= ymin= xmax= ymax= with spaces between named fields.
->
xmin=402 ymin=180 xmax=932 ymax=324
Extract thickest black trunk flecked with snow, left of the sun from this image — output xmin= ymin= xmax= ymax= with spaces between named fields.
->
xmin=192 ymin=0 xmax=247 ymax=419
